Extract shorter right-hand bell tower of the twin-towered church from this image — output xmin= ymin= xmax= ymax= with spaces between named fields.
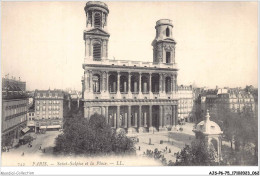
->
xmin=152 ymin=19 xmax=176 ymax=64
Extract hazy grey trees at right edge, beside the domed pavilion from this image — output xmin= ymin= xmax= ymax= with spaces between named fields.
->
xmin=211 ymin=104 xmax=258 ymax=165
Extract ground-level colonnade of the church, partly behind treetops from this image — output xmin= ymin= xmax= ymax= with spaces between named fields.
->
xmin=85 ymin=105 xmax=178 ymax=131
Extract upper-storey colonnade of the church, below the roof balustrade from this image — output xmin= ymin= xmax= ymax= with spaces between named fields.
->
xmin=84 ymin=70 xmax=177 ymax=94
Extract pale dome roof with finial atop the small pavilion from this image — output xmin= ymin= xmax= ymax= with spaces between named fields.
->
xmin=193 ymin=110 xmax=223 ymax=135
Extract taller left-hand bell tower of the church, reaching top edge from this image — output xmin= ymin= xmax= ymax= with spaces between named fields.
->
xmin=84 ymin=1 xmax=110 ymax=63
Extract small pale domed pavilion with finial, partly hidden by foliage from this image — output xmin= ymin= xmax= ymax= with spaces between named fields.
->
xmin=193 ymin=110 xmax=223 ymax=162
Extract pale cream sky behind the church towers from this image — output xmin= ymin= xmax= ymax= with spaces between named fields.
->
xmin=1 ymin=1 xmax=258 ymax=90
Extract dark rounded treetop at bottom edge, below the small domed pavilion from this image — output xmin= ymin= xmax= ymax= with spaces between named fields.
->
xmin=175 ymin=141 xmax=218 ymax=166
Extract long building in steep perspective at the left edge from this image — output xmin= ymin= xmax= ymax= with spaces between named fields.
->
xmin=1 ymin=78 xmax=28 ymax=147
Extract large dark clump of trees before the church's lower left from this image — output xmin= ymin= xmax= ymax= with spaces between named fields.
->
xmin=54 ymin=114 xmax=135 ymax=155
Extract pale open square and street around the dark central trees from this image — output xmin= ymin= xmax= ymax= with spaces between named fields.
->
xmin=2 ymin=123 xmax=195 ymax=166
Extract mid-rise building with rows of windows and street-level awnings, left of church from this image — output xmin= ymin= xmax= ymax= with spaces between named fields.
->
xmin=34 ymin=90 xmax=64 ymax=132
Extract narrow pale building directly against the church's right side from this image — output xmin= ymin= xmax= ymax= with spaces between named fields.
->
xmin=178 ymin=85 xmax=195 ymax=123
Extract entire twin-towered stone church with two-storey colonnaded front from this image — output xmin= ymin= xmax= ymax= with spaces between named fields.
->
xmin=82 ymin=1 xmax=178 ymax=133
